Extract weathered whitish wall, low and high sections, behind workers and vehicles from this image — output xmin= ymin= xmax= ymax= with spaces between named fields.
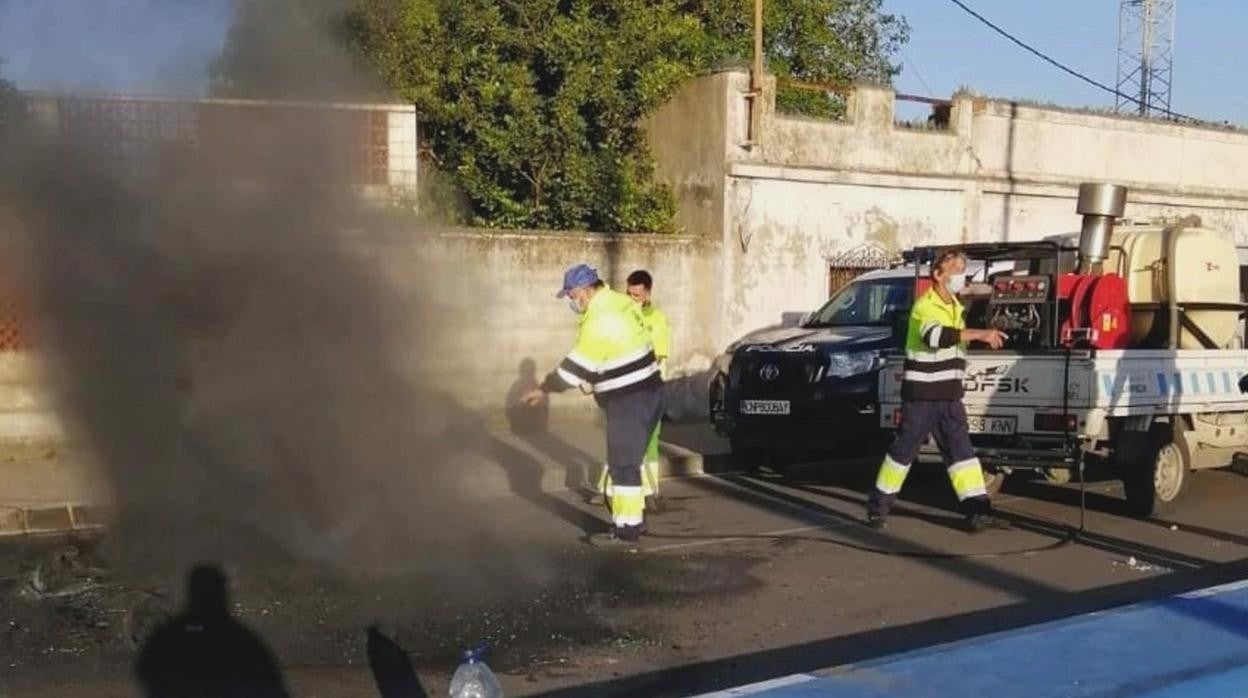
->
xmin=9 ymin=72 xmax=1248 ymax=431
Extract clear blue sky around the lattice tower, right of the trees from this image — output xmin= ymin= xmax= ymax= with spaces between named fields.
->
xmin=884 ymin=0 xmax=1248 ymax=124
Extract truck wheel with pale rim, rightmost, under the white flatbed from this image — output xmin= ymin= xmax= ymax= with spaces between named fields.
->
xmin=1118 ymin=425 xmax=1192 ymax=518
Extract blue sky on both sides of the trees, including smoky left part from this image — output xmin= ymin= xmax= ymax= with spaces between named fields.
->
xmin=0 ymin=0 xmax=1248 ymax=124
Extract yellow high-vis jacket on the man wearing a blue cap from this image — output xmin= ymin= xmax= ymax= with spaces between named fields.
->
xmin=542 ymin=287 xmax=663 ymax=401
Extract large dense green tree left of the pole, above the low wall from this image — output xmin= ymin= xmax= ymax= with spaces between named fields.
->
xmin=352 ymin=0 xmax=709 ymax=231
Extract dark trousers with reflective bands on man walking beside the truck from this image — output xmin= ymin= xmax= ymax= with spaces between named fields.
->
xmin=867 ymin=400 xmax=992 ymax=516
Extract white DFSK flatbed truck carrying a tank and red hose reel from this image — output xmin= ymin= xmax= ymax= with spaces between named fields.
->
xmin=879 ymin=184 xmax=1248 ymax=516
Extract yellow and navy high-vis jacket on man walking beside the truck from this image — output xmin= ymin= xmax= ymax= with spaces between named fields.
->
xmin=901 ymin=288 xmax=966 ymax=400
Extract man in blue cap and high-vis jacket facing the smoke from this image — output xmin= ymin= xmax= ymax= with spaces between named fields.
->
xmin=524 ymin=265 xmax=663 ymax=543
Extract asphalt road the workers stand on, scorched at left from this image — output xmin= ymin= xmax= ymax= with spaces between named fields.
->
xmin=0 ymin=465 xmax=1248 ymax=697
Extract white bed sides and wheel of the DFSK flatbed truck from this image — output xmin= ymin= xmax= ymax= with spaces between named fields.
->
xmin=880 ymin=350 xmax=1248 ymax=516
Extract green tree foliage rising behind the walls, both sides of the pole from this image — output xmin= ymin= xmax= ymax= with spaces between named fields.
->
xmin=217 ymin=0 xmax=909 ymax=231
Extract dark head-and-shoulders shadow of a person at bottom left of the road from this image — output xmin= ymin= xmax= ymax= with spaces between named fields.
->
xmin=136 ymin=564 xmax=290 ymax=698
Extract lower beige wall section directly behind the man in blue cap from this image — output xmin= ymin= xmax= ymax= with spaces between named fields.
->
xmin=364 ymin=230 xmax=721 ymax=416
